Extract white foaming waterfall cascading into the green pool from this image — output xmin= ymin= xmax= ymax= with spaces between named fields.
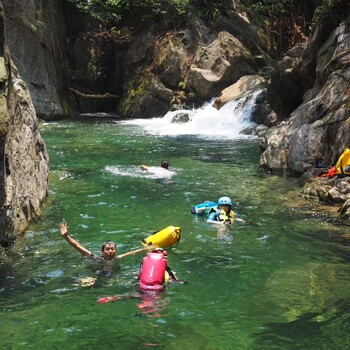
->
xmin=120 ymin=91 xmax=260 ymax=139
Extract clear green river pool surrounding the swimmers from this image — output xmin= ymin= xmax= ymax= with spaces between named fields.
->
xmin=0 ymin=108 xmax=350 ymax=350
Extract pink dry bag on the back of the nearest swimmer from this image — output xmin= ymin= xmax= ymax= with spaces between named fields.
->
xmin=140 ymin=249 xmax=167 ymax=290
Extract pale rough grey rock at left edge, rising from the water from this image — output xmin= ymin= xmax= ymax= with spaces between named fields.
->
xmin=0 ymin=43 xmax=49 ymax=246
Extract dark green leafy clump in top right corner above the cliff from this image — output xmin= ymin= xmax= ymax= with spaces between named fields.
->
xmin=312 ymin=0 xmax=350 ymax=27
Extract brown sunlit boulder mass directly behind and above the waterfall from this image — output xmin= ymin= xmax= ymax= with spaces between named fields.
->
xmin=118 ymin=13 xmax=271 ymax=118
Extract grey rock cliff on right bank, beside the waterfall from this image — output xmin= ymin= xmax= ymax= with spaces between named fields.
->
xmin=260 ymin=25 xmax=350 ymax=174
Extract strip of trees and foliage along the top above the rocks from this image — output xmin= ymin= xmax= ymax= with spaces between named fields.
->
xmin=69 ymin=0 xmax=350 ymax=52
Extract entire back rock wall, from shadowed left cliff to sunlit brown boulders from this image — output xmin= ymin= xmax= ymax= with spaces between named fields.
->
xmin=3 ymin=0 xmax=272 ymax=119
